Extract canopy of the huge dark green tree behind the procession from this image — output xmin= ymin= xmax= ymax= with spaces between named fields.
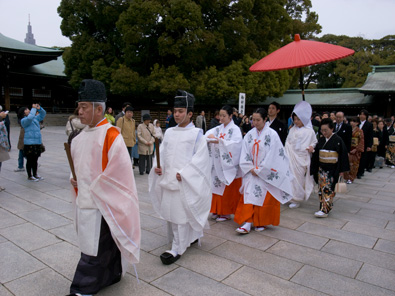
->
xmin=58 ymin=0 xmax=321 ymax=104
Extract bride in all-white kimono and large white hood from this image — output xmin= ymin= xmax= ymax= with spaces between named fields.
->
xmin=285 ymin=101 xmax=317 ymax=209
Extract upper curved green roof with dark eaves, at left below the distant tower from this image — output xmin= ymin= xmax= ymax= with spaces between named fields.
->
xmin=0 ymin=33 xmax=63 ymax=66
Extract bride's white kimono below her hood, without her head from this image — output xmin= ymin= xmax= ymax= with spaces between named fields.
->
xmin=285 ymin=126 xmax=317 ymax=202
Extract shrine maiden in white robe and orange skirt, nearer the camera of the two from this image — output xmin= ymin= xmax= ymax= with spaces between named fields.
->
xmin=234 ymin=108 xmax=293 ymax=234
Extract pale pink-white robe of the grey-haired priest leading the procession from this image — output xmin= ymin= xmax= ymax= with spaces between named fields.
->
xmin=71 ymin=120 xmax=141 ymax=264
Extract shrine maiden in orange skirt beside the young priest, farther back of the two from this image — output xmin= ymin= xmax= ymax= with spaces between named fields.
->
xmin=206 ymin=105 xmax=243 ymax=222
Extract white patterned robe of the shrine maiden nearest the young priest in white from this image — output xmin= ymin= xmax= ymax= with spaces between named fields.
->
xmin=205 ymin=120 xmax=243 ymax=196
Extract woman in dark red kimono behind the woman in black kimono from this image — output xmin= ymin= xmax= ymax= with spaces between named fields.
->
xmin=344 ymin=116 xmax=365 ymax=184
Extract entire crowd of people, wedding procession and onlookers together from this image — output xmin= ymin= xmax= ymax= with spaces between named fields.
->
xmin=0 ymin=79 xmax=395 ymax=295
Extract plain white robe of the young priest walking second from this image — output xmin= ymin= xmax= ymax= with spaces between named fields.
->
xmin=148 ymin=123 xmax=212 ymax=255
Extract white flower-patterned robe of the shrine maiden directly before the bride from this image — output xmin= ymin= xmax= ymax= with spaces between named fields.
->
xmin=240 ymin=124 xmax=292 ymax=206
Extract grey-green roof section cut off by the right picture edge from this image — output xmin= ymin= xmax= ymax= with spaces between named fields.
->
xmin=359 ymin=65 xmax=395 ymax=94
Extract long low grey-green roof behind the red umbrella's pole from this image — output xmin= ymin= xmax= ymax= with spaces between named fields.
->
xmin=260 ymin=88 xmax=373 ymax=106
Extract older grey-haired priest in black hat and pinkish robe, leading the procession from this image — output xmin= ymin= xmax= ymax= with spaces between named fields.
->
xmin=70 ymin=79 xmax=141 ymax=295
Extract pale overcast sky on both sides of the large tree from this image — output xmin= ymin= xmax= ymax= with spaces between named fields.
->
xmin=0 ymin=0 xmax=395 ymax=47
